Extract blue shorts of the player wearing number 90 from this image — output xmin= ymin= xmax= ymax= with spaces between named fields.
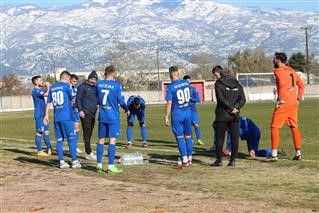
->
xmin=172 ymin=115 xmax=192 ymax=137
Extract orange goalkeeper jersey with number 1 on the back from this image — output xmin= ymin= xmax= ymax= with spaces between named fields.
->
xmin=274 ymin=65 xmax=305 ymax=105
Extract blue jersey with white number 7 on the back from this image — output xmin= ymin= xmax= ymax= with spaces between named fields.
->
xmin=95 ymin=80 xmax=128 ymax=123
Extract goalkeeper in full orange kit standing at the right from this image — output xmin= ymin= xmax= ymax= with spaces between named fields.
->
xmin=267 ymin=53 xmax=304 ymax=161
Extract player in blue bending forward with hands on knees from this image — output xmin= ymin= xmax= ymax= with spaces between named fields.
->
xmin=126 ymin=95 xmax=147 ymax=148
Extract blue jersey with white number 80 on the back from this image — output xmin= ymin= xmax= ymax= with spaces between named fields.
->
xmin=48 ymin=82 xmax=73 ymax=122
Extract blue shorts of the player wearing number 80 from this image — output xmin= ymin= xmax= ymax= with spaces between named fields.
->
xmin=54 ymin=121 xmax=75 ymax=140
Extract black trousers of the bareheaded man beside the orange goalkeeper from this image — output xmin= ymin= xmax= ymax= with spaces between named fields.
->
xmin=214 ymin=121 xmax=239 ymax=161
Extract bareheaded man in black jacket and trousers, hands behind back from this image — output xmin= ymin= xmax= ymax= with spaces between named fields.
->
xmin=211 ymin=65 xmax=246 ymax=166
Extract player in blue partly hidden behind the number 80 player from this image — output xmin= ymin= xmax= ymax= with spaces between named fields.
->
xmin=70 ymin=74 xmax=81 ymax=153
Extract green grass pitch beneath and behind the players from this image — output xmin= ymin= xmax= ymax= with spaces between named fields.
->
xmin=0 ymin=99 xmax=319 ymax=210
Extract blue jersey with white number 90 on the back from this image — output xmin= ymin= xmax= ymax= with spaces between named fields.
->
xmin=166 ymin=80 xmax=191 ymax=117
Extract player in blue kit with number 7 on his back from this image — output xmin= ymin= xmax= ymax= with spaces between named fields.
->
xmin=96 ymin=66 xmax=130 ymax=173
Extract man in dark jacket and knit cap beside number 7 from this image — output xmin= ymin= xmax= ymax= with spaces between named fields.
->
xmin=76 ymin=71 xmax=98 ymax=160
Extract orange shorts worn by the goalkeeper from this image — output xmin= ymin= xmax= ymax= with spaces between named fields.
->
xmin=271 ymin=104 xmax=298 ymax=128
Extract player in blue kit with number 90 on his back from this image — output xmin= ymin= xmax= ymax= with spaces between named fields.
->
xmin=165 ymin=66 xmax=193 ymax=167
